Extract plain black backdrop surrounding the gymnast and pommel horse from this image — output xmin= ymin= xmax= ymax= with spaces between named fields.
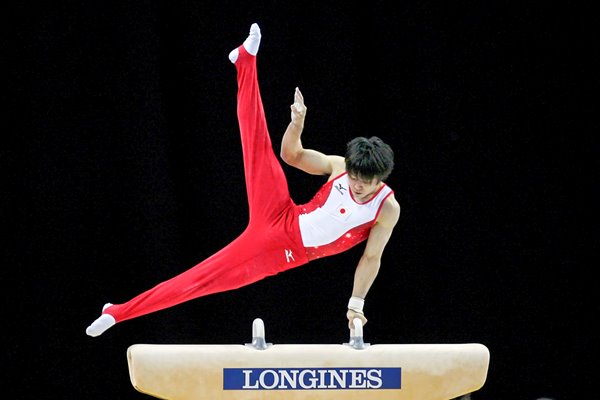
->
xmin=1 ymin=0 xmax=598 ymax=400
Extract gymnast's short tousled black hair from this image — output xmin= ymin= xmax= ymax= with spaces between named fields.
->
xmin=346 ymin=136 xmax=394 ymax=181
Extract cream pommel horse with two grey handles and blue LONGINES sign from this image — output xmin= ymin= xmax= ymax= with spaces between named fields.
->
xmin=127 ymin=318 xmax=490 ymax=400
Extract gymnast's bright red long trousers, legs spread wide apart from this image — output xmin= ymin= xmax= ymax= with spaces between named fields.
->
xmin=103 ymin=46 xmax=308 ymax=323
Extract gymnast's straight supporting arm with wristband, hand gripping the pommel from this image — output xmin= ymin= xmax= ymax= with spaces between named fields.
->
xmin=346 ymin=194 xmax=400 ymax=329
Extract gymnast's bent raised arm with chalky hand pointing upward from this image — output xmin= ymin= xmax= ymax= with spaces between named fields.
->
xmin=280 ymin=88 xmax=344 ymax=175
